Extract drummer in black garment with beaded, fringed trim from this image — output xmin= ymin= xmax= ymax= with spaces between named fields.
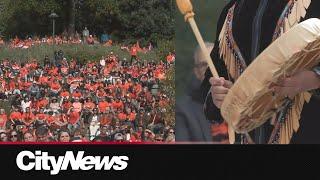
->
xmin=202 ymin=0 xmax=320 ymax=144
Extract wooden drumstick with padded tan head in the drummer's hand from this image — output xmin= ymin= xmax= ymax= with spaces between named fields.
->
xmin=176 ymin=0 xmax=235 ymax=144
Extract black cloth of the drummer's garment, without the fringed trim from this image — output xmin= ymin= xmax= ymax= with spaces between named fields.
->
xmin=201 ymin=0 xmax=320 ymax=143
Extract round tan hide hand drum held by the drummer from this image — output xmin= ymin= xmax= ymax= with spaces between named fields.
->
xmin=221 ymin=18 xmax=320 ymax=133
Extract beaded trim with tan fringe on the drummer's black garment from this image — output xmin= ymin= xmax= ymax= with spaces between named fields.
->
xmin=219 ymin=0 xmax=311 ymax=144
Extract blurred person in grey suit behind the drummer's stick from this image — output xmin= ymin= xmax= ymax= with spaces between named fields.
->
xmin=175 ymin=43 xmax=218 ymax=142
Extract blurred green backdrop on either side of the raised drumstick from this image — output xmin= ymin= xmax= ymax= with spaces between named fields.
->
xmin=175 ymin=0 xmax=227 ymax=98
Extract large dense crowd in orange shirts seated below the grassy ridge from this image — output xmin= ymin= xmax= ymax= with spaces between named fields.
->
xmin=0 ymin=48 xmax=175 ymax=142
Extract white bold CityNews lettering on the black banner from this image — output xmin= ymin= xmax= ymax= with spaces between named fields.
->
xmin=16 ymin=151 xmax=129 ymax=175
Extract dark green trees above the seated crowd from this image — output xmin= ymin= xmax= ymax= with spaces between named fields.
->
xmin=0 ymin=0 xmax=175 ymax=42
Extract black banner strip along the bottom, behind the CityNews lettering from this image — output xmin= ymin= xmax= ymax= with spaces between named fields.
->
xmin=0 ymin=144 xmax=320 ymax=180
